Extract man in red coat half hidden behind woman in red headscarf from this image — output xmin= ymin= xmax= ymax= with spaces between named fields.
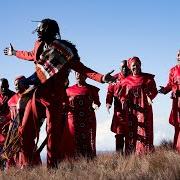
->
xmin=106 ymin=60 xmax=129 ymax=154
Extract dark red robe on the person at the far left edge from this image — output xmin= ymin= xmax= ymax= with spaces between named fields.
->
xmin=0 ymin=90 xmax=14 ymax=148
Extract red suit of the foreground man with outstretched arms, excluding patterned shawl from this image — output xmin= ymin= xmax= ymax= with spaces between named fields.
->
xmin=16 ymin=38 xmax=103 ymax=167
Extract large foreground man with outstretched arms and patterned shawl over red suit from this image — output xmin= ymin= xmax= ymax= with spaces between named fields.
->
xmin=4 ymin=19 xmax=115 ymax=168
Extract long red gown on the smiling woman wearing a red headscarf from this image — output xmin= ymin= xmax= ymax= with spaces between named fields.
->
xmin=122 ymin=73 xmax=157 ymax=154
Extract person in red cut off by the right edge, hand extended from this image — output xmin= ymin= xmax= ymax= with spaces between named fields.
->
xmin=159 ymin=50 xmax=180 ymax=152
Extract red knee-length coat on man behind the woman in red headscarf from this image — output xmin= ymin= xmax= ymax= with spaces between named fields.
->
xmin=106 ymin=73 xmax=127 ymax=134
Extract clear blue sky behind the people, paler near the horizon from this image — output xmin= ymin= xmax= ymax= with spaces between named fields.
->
xmin=0 ymin=0 xmax=180 ymax=150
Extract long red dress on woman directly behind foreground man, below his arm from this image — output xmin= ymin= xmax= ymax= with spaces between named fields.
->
xmin=60 ymin=84 xmax=100 ymax=158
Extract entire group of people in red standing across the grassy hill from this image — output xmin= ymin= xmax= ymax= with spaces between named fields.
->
xmin=0 ymin=19 xmax=180 ymax=171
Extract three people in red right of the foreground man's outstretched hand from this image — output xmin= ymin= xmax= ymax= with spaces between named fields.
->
xmin=106 ymin=51 xmax=180 ymax=154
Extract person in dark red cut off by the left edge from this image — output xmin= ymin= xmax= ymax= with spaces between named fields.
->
xmin=0 ymin=78 xmax=14 ymax=169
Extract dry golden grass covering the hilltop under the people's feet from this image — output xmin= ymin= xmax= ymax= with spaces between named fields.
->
xmin=0 ymin=149 xmax=180 ymax=180
